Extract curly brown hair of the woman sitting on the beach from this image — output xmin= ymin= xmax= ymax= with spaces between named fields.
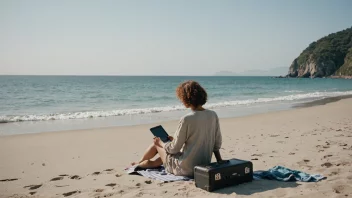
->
xmin=176 ymin=80 xmax=208 ymax=107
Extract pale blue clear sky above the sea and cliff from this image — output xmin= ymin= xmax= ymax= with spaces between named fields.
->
xmin=0 ymin=0 xmax=352 ymax=75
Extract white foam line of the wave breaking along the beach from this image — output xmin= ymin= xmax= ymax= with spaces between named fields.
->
xmin=0 ymin=91 xmax=352 ymax=123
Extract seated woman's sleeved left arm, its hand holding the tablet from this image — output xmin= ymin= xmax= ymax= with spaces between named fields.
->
xmin=164 ymin=118 xmax=187 ymax=154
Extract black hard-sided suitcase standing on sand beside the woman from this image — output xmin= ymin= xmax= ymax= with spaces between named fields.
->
xmin=194 ymin=159 xmax=253 ymax=192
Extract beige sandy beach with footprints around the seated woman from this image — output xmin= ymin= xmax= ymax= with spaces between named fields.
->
xmin=0 ymin=99 xmax=352 ymax=198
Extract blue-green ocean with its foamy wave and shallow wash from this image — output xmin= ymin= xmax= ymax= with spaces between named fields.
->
xmin=0 ymin=76 xmax=352 ymax=135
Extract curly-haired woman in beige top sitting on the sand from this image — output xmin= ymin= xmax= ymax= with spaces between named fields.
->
xmin=132 ymin=81 xmax=222 ymax=176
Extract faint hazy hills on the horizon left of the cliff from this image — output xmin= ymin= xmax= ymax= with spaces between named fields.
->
xmin=214 ymin=67 xmax=287 ymax=76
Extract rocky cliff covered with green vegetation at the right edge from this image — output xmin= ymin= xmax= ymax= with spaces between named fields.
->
xmin=288 ymin=28 xmax=352 ymax=78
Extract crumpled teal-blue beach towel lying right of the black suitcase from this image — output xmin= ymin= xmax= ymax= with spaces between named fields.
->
xmin=253 ymin=166 xmax=326 ymax=182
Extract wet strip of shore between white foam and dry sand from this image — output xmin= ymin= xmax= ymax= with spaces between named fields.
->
xmin=0 ymin=95 xmax=352 ymax=137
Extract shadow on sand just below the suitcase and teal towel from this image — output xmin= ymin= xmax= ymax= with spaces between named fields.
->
xmin=213 ymin=180 xmax=301 ymax=195
